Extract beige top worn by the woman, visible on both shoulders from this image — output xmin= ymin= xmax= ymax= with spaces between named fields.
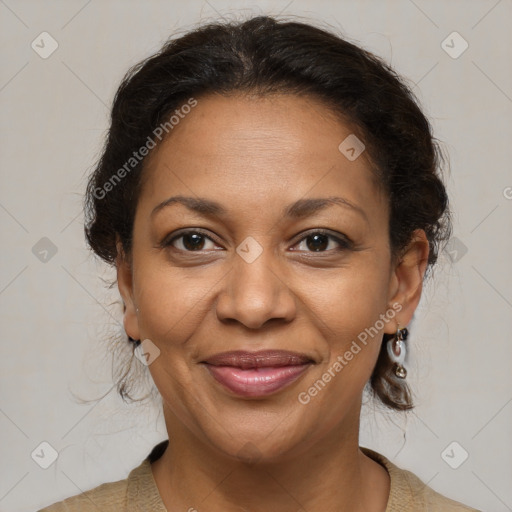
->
xmin=39 ymin=440 xmax=479 ymax=512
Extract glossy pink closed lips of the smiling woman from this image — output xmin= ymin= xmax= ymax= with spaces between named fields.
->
xmin=204 ymin=350 xmax=314 ymax=397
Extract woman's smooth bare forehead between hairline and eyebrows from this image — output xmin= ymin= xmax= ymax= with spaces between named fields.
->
xmin=141 ymin=94 xmax=383 ymax=222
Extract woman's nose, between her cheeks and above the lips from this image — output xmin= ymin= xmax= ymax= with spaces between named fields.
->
xmin=216 ymin=249 xmax=296 ymax=329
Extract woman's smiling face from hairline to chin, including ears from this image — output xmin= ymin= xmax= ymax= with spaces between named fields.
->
xmin=118 ymin=95 xmax=428 ymax=460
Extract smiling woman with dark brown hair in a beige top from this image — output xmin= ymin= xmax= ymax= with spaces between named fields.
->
xmin=40 ymin=17 xmax=480 ymax=512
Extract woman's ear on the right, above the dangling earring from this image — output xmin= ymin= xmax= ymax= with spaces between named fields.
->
xmin=384 ymin=229 xmax=429 ymax=334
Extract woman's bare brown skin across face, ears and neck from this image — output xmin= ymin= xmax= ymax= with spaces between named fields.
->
xmin=117 ymin=94 xmax=428 ymax=512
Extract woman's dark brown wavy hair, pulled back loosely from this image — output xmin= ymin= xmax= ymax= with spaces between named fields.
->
xmin=85 ymin=16 xmax=451 ymax=410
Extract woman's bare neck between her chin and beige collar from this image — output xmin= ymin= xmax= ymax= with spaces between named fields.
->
xmin=152 ymin=406 xmax=389 ymax=512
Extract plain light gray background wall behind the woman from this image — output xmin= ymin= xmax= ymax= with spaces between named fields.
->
xmin=0 ymin=0 xmax=512 ymax=512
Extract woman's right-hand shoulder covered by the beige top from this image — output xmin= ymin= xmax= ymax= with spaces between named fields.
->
xmin=361 ymin=447 xmax=479 ymax=512
